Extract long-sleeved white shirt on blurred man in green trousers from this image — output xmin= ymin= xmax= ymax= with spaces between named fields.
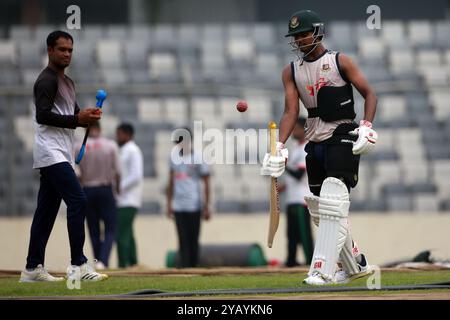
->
xmin=117 ymin=140 xmax=144 ymax=208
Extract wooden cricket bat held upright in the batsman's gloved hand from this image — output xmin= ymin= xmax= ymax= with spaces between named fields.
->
xmin=267 ymin=121 xmax=280 ymax=248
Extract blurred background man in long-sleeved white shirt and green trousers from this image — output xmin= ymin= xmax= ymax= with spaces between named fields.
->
xmin=116 ymin=123 xmax=144 ymax=268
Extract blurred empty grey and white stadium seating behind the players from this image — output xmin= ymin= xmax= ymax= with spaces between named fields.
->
xmin=0 ymin=20 xmax=450 ymax=215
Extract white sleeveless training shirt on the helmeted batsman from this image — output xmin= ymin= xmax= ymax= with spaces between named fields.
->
xmin=291 ymin=50 xmax=352 ymax=142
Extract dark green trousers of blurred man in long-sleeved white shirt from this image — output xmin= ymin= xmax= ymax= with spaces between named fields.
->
xmin=117 ymin=207 xmax=137 ymax=268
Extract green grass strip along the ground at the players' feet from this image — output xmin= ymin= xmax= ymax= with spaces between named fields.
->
xmin=0 ymin=271 xmax=450 ymax=297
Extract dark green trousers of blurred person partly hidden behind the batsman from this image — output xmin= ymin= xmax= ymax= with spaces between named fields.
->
xmin=286 ymin=204 xmax=314 ymax=266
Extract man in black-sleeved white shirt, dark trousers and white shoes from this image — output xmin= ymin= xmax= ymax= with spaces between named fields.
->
xmin=20 ymin=31 xmax=107 ymax=282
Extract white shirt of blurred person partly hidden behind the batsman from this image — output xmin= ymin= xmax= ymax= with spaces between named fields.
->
xmin=285 ymin=141 xmax=311 ymax=205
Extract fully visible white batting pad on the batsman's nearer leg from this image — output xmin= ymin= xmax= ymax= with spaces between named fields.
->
xmin=308 ymin=177 xmax=350 ymax=280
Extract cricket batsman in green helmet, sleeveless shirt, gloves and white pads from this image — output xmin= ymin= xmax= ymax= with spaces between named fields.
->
xmin=262 ymin=10 xmax=377 ymax=285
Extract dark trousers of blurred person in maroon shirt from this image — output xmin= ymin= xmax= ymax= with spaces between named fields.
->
xmin=84 ymin=186 xmax=117 ymax=266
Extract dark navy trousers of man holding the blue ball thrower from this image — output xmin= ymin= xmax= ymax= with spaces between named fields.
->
xmin=26 ymin=162 xmax=87 ymax=269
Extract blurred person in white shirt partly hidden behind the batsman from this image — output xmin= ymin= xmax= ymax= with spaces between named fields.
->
xmin=283 ymin=117 xmax=314 ymax=267
